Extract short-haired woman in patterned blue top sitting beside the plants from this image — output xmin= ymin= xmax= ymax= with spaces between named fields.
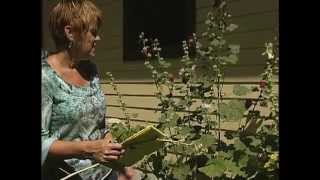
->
xmin=41 ymin=0 xmax=133 ymax=180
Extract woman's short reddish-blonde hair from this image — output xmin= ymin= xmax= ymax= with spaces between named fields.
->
xmin=49 ymin=0 xmax=102 ymax=48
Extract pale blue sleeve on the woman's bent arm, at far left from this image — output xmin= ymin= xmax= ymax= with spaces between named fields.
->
xmin=41 ymin=69 xmax=57 ymax=165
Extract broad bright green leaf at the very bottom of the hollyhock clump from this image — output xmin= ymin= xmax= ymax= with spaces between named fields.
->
xmin=199 ymin=160 xmax=226 ymax=177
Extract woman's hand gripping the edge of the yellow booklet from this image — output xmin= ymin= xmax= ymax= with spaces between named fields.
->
xmin=92 ymin=139 xmax=124 ymax=162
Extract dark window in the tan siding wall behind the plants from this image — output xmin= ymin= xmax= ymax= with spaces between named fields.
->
xmin=123 ymin=0 xmax=195 ymax=61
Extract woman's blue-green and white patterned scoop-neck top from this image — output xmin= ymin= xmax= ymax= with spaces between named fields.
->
xmin=41 ymin=52 xmax=115 ymax=179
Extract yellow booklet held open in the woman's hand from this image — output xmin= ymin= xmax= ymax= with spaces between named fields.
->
xmin=113 ymin=126 xmax=167 ymax=166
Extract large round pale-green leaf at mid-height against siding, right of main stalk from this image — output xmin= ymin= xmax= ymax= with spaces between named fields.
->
xmin=220 ymin=100 xmax=246 ymax=121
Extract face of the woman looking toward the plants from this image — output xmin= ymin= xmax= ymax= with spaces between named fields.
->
xmin=75 ymin=26 xmax=100 ymax=58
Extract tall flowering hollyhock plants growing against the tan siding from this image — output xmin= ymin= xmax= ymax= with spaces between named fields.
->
xmin=104 ymin=0 xmax=279 ymax=180
